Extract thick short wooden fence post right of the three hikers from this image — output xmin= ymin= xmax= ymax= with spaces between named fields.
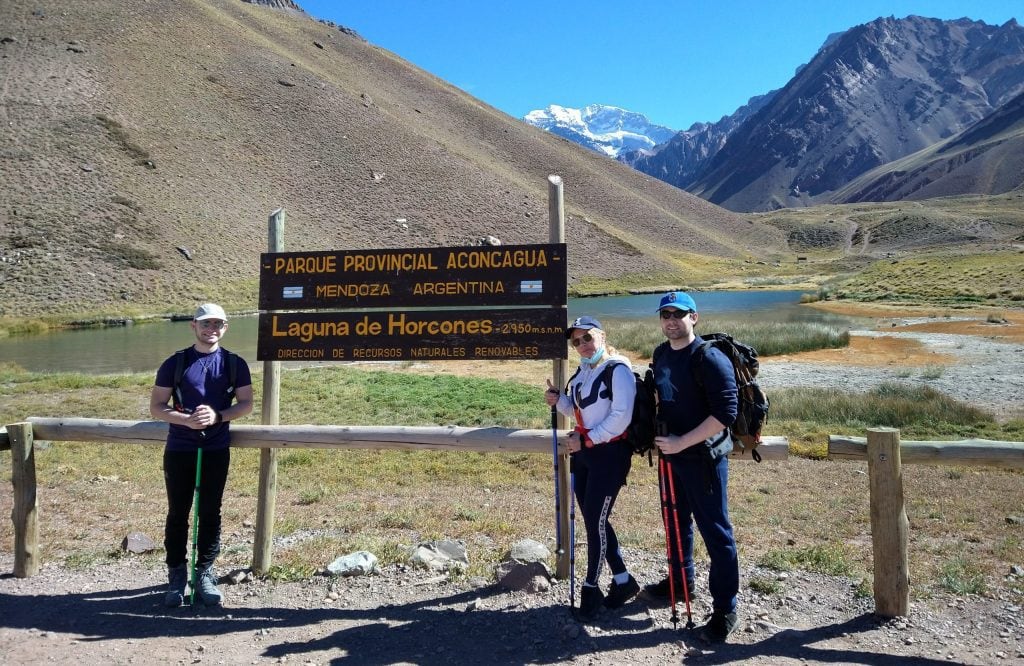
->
xmin=867 ymin=428 xmax=910 ymax=618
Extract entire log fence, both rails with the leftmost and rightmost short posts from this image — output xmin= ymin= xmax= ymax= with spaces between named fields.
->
xmin=6 ymin=417 xmax=1024 ymax=617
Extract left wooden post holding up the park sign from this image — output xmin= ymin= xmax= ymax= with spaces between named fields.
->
xmin=252 ymin=208 xmax=285 ymax=576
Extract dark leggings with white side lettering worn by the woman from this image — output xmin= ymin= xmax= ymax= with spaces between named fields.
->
xmin=571 ymin=442 xmax=633 ymax=585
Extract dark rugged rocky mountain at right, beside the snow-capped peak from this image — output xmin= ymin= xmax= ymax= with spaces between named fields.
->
xmin=524 ymin=16 xmax=1024 ymax=211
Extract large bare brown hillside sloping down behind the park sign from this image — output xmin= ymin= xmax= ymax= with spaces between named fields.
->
xmin=0 ymin=0 xmax=785 ymax=316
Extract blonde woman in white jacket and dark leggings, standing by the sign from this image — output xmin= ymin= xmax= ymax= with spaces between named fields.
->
xmin=545 ymin=317 xmax=640 ymax=619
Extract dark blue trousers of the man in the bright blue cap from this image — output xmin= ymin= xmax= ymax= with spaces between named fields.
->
xmin=665 ymin=455 xmax=739 ymax=613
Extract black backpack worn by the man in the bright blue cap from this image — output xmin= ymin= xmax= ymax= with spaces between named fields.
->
xmin=693 ymin=333 xmax=768 ymax=462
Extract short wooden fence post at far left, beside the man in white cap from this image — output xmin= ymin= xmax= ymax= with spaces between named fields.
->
xmin=7 ymin=423 xmax=39 ymax=578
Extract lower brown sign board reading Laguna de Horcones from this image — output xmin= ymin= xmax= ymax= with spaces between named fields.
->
xmin=256 ymin=307 xmax=567 ymax=361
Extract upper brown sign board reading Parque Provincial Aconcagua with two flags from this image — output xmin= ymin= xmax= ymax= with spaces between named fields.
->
xmin=253 ymin=244 xmax=567 ymax=310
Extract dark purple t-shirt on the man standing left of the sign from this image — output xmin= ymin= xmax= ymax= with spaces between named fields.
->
xmin=156 ymin=346 xmax=252 ymax=451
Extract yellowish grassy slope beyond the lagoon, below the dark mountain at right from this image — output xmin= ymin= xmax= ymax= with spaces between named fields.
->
xmin=755 ymin=193 xmax=1024 ymax=307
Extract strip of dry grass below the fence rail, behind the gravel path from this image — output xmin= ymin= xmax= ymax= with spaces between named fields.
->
xmin=0 ymin=436 xmax=1024 ymax=596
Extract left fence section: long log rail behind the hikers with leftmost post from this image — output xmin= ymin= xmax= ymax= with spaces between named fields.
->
xmin=0 ymin=417 xmax=790 ymax=578
